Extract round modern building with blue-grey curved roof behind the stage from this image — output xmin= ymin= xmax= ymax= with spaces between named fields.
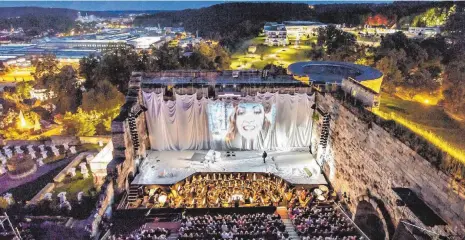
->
xmin=287 ymin=61 xmax=383 ymax=93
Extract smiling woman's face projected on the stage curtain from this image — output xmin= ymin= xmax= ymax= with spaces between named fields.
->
xmin=236 ymin=103 xmax=265 ymax=139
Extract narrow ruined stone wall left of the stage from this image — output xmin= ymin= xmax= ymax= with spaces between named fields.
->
xmin=92 ymin=73 xmax=149 ymax=236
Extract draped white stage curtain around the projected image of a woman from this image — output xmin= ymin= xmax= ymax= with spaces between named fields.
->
xmin=143 ymin=92 xmax=315 ymax=150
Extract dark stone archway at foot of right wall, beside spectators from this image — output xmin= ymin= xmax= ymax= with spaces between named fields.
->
xmin=353 ymin=195 xmax=393 ymax=240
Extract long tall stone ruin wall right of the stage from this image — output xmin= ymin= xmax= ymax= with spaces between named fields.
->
xmin=317 ymin=94 xmax=465 ymax=237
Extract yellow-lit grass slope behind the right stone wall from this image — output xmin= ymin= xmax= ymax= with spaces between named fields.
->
xmin=379 ymin=93 xmax=465 ymax=162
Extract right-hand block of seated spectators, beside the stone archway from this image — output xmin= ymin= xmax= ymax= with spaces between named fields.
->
xmin=289 ymin=204 xmax=361 ymax=240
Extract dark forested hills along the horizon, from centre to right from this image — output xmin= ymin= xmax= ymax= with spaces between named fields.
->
xmin=134 ymin=2 xmax=452 ymax=47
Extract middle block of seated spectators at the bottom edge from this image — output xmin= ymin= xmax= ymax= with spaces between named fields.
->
xmin=178 ymin=213 xmax=289 ymax=240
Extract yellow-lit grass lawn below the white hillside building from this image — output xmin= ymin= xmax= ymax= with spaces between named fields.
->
xmin=231 ymin=37 xmax=311 ymax=69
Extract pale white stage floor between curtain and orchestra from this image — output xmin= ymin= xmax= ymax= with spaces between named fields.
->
xmin=131 ymin=150 xmax=327 ymax=185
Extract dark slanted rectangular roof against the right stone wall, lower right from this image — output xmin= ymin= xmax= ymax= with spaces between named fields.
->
xmin=392 ymin=188 xmax=447 ymax=227
